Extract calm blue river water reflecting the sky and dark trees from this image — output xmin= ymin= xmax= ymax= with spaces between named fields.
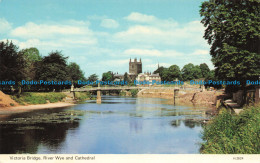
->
xmin=0 ymin=96 xmax=215 ymax=154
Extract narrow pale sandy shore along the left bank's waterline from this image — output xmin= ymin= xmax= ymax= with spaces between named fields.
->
xmin=0 ymin=102 xmax=76 ymax=118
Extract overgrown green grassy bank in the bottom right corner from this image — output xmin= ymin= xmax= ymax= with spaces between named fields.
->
xmin=201 ymin=105 xmax=260 ymax=154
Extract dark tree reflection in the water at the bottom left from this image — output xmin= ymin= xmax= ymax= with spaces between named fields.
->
xmin=0 ymin=122 xmax=79 ymax=154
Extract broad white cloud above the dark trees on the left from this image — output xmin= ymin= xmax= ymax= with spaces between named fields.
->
xmin=9 ymin=20 xmax=98 ymax=53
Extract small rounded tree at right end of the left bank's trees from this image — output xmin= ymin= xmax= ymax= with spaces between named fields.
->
xmin=68 ymin=62 xmax=86 ymax=81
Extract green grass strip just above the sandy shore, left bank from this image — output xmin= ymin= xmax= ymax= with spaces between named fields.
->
xmin=12 ymin=92 xmax=66 ymax=105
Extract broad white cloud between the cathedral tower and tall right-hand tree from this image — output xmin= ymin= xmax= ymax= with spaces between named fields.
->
xmin=114 ymin=14 xmax=207 ymax=47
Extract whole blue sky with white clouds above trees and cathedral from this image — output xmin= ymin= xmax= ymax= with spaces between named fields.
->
xmin=0 ymin=0 xmax=214 ymax=77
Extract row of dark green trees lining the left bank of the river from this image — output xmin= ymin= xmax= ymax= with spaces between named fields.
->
xmin=0 ymin=40 xmax=86 ymax=91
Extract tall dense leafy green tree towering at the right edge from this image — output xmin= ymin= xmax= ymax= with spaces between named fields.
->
xmin=200 ymin=0 xmax=260 ymax=85
